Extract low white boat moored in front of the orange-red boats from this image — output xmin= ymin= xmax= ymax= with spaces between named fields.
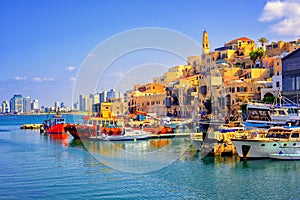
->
xmin=90 ymin=127 xmax=150 ymax=141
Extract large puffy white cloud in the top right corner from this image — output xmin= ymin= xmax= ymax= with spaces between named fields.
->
xmin=259 ymin=0 xmax=300 ymax=37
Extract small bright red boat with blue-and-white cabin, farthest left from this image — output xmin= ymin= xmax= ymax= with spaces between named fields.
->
xmin=40 ymin=114 xmax=68 ymax=139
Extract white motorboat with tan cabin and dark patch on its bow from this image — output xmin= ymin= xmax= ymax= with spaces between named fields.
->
xmin=231 ymin=127 xmax=300 ymax=159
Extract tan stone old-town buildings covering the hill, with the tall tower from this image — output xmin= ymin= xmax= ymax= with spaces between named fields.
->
xmin=78 ymin=31 xmax=300 ymax=117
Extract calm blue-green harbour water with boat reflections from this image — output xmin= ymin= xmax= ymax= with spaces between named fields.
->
xmin=0 ymin=115 xmax=300 ymax=199
